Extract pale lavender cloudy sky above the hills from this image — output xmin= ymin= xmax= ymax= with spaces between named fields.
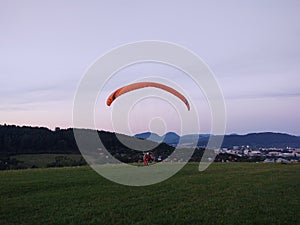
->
xmin=0 ymin=0 xmax=300 ymax=135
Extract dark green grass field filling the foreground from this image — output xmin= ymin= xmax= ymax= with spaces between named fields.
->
xmin=0 ymin=163 xmax=300 ymax=225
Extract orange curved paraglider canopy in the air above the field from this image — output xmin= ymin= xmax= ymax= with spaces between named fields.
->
xmin=106 ymin=82 xmax=190 ymax=110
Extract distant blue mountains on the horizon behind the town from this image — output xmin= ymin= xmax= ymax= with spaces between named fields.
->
xmin=135 ymin=132 xmax=300 ymax=148
